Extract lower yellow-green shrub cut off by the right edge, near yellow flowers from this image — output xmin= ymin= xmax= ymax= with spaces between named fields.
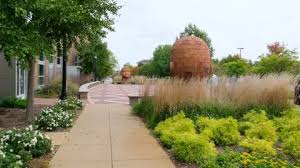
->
xmin=282 ymin=131 xmax=300 ymax=161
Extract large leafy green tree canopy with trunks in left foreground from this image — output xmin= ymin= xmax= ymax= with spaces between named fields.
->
xmin=0 ymin=0 xmax=120 ymax=120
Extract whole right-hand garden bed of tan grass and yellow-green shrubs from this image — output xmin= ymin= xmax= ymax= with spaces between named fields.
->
xmin=133 ymin=75 xmax=300 ymax=168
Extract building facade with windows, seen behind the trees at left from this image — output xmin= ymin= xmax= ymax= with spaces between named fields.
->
xmin=0 ymin=47 xmax=91 ymax=98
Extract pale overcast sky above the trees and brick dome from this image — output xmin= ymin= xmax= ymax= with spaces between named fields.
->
xmin=107 ymin=0 xmax=300 ymax=67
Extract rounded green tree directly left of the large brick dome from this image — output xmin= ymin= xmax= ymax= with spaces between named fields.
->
xmin=151 ymin=45 xmax=172 ymax=77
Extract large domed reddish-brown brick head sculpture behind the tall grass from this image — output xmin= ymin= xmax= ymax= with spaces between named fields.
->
xmin=170 ymin=36 xmax=212 ymax=79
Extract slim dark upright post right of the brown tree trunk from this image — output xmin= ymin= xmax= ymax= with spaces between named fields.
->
xmin=60 ymin=37 xmax=68 ymax=100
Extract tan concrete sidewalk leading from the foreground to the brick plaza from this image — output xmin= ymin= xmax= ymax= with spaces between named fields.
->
xmin=50 ymin=104 xmax=174 ymax=168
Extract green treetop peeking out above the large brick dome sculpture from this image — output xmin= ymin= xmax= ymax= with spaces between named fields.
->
xmin=180 ymin=24 xmax=215 ymax=57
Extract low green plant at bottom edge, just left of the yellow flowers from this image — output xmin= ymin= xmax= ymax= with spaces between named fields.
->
xmin=216 ymin=148 xmax=242 ymax=168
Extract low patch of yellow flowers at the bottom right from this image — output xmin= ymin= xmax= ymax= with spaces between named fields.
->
xmin=242 ymin=152 xmax=293 ymax=168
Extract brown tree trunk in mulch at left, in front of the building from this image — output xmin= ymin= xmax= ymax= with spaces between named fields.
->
xmin=26 ymin=58 xmax=35 ymax=123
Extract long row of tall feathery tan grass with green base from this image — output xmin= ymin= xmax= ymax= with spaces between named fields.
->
xmin=137 ymin=74 xmax=293 ymax=125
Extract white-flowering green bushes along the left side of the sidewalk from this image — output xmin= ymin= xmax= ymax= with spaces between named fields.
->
xmin=0 ymin=97 xmax=83 ymax=168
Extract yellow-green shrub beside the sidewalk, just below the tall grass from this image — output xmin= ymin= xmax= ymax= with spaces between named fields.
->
xmin=154 ymin=112 xmax=196 ymax=147
